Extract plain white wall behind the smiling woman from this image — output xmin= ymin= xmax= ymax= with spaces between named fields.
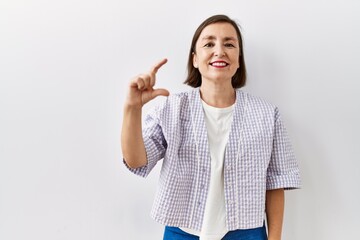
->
xmin=0 ymin=0 xmax=360 ymax=240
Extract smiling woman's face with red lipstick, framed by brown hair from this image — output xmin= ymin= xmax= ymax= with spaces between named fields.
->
xmin=193 ymin=23 xmax=240 ymax=84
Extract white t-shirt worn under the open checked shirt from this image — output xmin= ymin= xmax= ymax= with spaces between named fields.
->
xmin=181 ymin=101 xmax=234 ymax=240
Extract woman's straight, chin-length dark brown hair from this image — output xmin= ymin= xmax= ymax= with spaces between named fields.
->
xmin=184 ymin=15 xmax=246 ymax=88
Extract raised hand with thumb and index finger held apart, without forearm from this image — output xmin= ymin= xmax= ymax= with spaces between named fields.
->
xmin=125 ymin=58 xmax=169 ymax=108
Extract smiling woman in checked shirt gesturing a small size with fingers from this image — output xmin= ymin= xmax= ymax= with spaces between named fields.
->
xmin=121 ymin=15 xmax=300 ymax=240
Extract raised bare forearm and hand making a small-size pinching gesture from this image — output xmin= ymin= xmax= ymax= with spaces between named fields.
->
xmin=121 ymin=59 xmax=169 ymax=168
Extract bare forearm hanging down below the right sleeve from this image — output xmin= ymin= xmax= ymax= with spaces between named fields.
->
xmin=266 ymin=188 xmax=285 ymax=240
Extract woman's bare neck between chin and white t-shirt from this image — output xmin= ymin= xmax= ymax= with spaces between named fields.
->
xmin=200 ymin=82 xmax=236 ymax=108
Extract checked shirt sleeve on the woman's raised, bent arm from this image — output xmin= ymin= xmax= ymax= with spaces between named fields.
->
xmin=123 ymin=106 xmax=167 ymax=177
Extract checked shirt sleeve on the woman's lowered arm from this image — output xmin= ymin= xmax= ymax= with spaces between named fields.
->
xmin=266 ymin=108 xmax=301 ymax=190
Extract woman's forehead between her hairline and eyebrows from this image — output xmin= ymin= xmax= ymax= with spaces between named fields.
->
xmin=198 ymin=23 xmax=237 ymax=41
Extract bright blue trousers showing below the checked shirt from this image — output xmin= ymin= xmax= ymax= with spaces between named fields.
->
xmin=163 ymin=224 xmax=267 ymax=240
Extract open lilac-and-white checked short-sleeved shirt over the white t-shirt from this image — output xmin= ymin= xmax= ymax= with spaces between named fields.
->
xmin=124 ymin=88 xmax=300 ymax=231
